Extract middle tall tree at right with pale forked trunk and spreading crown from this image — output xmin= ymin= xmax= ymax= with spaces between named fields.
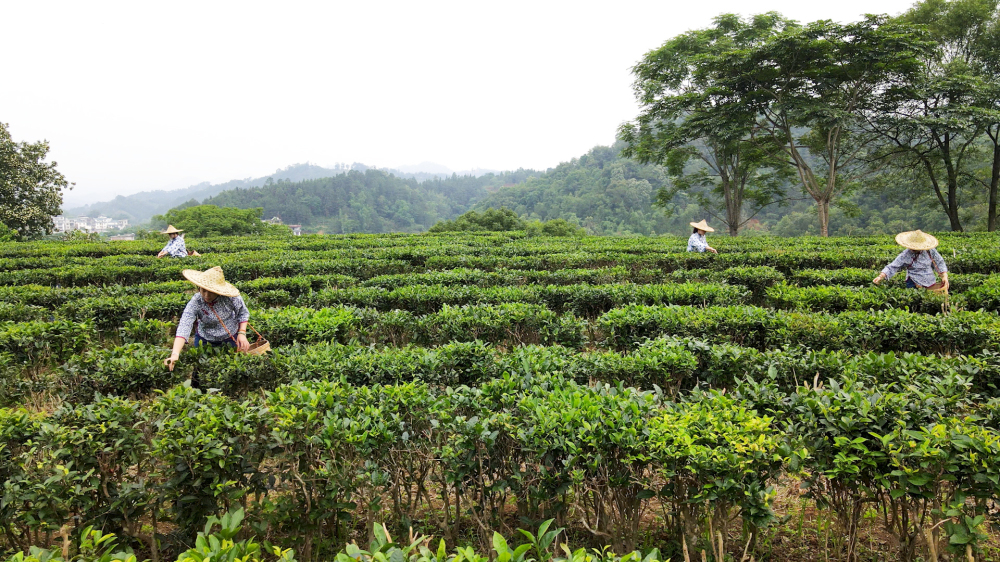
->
xmin=711 ymin=16 xmax=933 ymax=236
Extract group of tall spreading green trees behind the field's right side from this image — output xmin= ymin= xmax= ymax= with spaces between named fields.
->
xmin=619 ymin=7 xmax=1000 ymax=235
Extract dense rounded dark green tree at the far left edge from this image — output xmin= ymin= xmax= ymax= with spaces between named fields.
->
xmin=0 ymin=123 xmax=73 ymax=238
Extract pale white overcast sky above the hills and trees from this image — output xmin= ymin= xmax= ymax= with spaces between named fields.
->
xmin=0 ymin=0 xmax=913 ymax=203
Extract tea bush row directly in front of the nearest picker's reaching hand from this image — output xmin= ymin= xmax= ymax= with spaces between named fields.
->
xmin=59 ymin=338 xmax=1000 ymax=402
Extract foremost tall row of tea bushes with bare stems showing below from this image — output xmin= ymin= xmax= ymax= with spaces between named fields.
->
xmin=0 ymin=375 xmax=1000 ymax=560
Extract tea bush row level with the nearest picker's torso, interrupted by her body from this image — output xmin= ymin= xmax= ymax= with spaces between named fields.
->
xmin=7 ymin=294 xmax=1000 ymax=376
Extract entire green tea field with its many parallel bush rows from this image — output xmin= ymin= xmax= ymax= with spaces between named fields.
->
xmin=0 ymin=233 xmax=1000 ymax=562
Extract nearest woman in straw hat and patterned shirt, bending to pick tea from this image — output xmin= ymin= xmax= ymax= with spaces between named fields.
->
xmin=163 ymin=266 xmax=250 ymax=371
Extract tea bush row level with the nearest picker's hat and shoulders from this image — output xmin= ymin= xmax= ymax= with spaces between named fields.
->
xmin=7 ymin=274 xmax=1000 ymax=327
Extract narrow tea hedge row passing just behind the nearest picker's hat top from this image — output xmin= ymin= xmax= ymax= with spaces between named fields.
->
xmin=0 ymin=237 xmax=1000 ymax=286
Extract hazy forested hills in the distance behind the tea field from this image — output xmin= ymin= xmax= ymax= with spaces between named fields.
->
xmin=178 ymin=142 xmax=964 ymax=236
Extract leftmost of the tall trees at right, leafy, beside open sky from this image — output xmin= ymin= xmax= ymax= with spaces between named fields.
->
xmin=618 ymin=12 xmax=793 ymax=236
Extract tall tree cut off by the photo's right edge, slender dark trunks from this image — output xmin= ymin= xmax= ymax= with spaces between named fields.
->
xmin=867 ymin=0 xmax=1000 ymax=231
